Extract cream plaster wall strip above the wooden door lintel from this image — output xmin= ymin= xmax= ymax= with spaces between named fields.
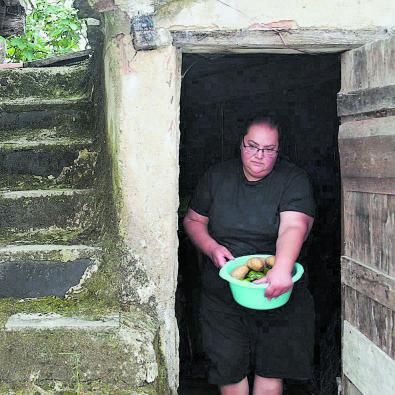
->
xmin=156 ymin=0 xmax=395 ymax=30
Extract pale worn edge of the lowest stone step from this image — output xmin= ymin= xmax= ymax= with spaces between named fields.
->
xmin=4 ymin=313 xmax=121 ymax=331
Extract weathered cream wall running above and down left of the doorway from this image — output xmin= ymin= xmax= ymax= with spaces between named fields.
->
xmin=96 ymin=0 xmax=395 ymax=392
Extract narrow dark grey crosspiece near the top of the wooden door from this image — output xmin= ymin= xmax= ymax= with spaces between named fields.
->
xmin=337 ymin=85 xmax=395 ymax=117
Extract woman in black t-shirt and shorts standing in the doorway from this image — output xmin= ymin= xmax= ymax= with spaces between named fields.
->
xmin=184 ymin=118 xmax=315 ymax=395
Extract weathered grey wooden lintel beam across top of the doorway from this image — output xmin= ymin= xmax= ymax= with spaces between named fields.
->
xmin=171 ymin=29 xmax=389 ymax=53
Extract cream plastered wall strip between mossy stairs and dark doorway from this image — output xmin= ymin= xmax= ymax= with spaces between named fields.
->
xmin=105 ymin=8 xmax=180 ymax=393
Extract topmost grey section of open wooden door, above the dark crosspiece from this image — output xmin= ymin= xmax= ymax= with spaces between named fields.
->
xmin=341 ymin=36 xmax=395 ymax=93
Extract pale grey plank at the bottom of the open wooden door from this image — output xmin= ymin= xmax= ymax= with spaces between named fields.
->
xmin=342 ymin=321 xmax=395 ymax=395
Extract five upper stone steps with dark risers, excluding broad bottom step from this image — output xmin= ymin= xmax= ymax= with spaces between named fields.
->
xmin=0 ymin=61 xmax=100 ymax=298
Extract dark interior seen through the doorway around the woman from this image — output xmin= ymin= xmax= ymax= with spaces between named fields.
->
xmin=176 ymin=54 xmax=341 ymax=395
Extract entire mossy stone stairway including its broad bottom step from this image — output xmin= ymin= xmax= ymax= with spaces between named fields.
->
xmin=0 ymin=60 xmax=166 ymax=394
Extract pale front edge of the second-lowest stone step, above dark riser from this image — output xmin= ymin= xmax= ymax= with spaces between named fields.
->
xmin=0 ymin=244 xmax=102 ymax=265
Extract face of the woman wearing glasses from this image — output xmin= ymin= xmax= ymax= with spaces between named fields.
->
xmin=240 ymin=123 xmax=279 ymax=181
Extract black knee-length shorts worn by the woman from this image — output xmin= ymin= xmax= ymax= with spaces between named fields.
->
xmin=200 ymin=262 xmax=314 ymax=385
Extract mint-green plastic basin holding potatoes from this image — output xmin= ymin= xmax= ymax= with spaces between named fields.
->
xmin=219 ymin=254 xmax=304 ymax=310
